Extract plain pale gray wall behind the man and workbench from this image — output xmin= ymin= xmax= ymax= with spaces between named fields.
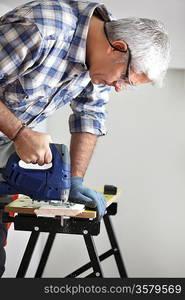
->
xmin=1 ymin=0 xmax=185 ymax=277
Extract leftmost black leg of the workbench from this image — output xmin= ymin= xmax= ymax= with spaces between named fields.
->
xmin=16 ymin=231 xmax=40 ymax=278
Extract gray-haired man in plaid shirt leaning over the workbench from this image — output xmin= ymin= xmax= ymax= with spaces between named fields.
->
xmin=0 ymin=0 xmax=169 ymax=275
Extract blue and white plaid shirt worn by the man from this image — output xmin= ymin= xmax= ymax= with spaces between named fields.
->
xmin=0 ymin=0 xmax=111 ymax=139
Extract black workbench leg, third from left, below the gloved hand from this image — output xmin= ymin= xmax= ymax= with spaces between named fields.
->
xmin=83 ymin=234 xmax=103 ymax=278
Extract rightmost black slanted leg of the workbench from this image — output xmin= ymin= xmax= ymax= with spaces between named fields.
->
xmin=103 ymin=215 xmax=127 ymax=278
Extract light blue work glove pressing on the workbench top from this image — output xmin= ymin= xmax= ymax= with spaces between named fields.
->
xmin=69 ymin=177 xmax=106 ymax=221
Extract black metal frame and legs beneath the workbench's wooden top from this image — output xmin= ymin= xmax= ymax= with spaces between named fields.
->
xmin=13 ymin=203 xmax=127 ymax=278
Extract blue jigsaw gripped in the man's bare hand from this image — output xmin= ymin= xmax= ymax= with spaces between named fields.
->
xmin=0 ymin=143 xmax=71 ymax=202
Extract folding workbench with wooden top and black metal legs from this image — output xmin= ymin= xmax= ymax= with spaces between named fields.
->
xmin=3 ymin=189 xmax=127 ymax=278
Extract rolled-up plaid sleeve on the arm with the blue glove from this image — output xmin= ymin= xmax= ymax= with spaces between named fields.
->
xmin=69 ymin=82 xmax=110 ymax=136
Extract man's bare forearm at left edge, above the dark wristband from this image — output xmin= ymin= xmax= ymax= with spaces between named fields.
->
xmin=0 ymin=100 xmax=22 ymax=139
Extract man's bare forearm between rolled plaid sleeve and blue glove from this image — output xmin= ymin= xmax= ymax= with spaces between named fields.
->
xmin=70 ymin=132 xmax=97 ymax=177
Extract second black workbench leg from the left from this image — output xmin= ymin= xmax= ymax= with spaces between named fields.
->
xmin=35 ymin=233 xmax=56 ymax=278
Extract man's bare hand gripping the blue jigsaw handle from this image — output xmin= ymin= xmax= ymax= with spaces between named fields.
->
xmin=14 ymin=128 xmax=52 ymax=166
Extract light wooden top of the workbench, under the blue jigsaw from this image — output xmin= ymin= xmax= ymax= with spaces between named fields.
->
xmin=4 ymin=189 xmax=120 ymax=219
